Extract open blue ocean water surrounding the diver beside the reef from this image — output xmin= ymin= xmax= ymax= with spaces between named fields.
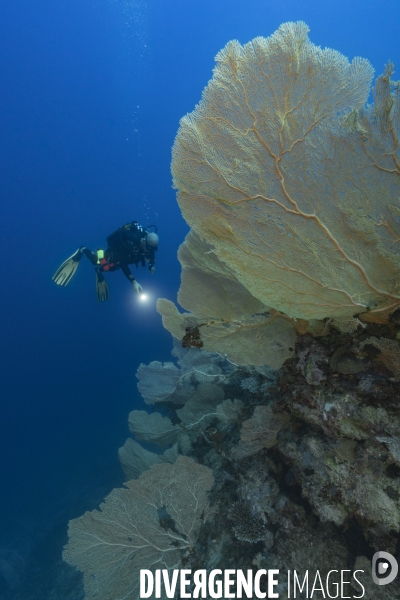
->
xmin=0 ymin=0 xmax=400 ymax=600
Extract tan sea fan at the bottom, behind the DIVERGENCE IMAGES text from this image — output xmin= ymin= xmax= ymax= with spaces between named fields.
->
xmin=63 ymin=456 xmax=214 ymax=600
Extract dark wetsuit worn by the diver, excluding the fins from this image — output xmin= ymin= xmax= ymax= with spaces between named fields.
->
xmin=82 ymin=221 xmax=155 ymax=282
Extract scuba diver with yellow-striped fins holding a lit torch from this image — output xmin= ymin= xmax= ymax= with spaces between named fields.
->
xmin=52 ymin=221 xmax=159 ymax=302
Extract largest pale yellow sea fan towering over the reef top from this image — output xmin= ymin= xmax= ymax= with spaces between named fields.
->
xmin=172 ymin=22 xmax=400 ymax=320
